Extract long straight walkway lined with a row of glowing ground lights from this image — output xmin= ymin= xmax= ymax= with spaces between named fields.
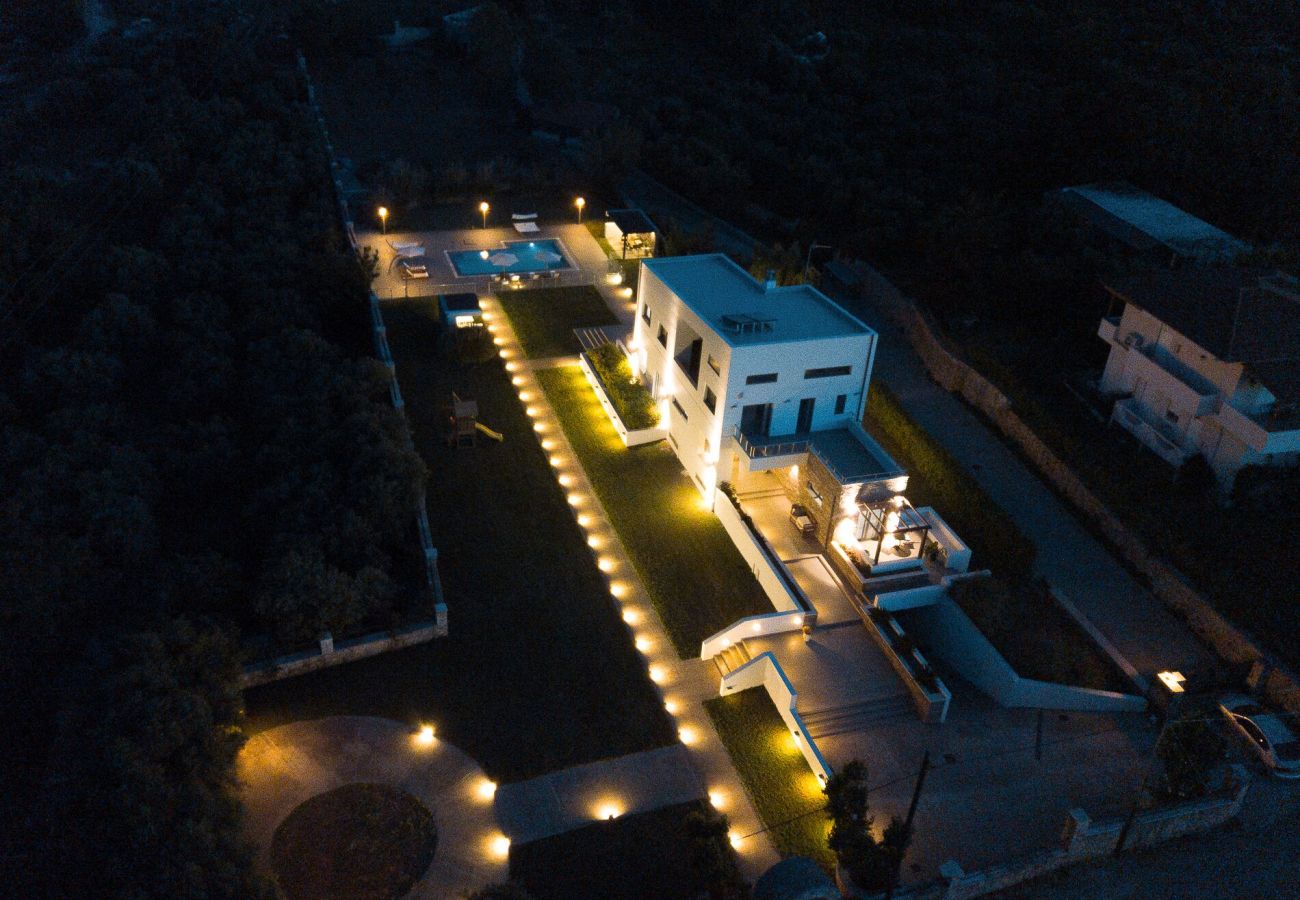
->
xmin=480 ymin=298 xmax=780 ymax=880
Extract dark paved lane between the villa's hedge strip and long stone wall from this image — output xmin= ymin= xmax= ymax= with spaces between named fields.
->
xmin=840 ymin=274 xmax=1219 ymax=680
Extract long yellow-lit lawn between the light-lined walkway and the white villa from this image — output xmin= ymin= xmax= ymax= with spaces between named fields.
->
xmin=537 ymin=365 xmax=772 ymax=658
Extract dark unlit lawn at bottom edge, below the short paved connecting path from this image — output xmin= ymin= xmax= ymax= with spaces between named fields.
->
xmin=510 ymin=801 xmax=743 ymax=900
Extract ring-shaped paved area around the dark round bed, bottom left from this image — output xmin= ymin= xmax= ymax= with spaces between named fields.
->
xmin=238 ymin=715 xmax=507 ymax=897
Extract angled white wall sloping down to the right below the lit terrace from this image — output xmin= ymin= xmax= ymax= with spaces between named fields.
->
xmin=909 ymin=597 xmax=1147 ymax=713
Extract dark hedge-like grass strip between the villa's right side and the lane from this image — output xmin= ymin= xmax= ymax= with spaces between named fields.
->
xmin=862 ymin=381 xmax=1035 ymax=579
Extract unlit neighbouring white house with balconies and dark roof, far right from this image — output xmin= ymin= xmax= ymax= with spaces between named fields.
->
xmin=1099 ymin=268 xmax=1300 ymax=488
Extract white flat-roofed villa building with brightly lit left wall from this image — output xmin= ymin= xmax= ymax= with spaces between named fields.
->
xmin=629 ymin=254 xmax=906 ymax=512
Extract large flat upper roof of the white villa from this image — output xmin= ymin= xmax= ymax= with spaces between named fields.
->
xmin=642 ymin=254 xmax=875 ymax=347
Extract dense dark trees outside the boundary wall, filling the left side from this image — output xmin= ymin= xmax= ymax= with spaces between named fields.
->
xmin=0 ymin=0 xmax=424 ymax=897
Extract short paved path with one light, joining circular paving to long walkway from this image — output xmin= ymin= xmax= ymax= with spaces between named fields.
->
xmin=497 ymin=744 xmax=709 ymax=844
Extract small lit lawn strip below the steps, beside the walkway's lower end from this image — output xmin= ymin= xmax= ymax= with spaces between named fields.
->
xmin=705 ymin=688 xmax=835 ymax=871
